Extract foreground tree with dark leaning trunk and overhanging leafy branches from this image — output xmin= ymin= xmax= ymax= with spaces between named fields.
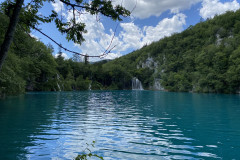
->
xmin=0 ymin=0 xmax=130 ymax=70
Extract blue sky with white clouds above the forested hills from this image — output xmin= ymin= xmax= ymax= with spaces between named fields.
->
xmin=1 ymin=0 xmax=240 ymax=61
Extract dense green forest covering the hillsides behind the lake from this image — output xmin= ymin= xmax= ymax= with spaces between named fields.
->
xmin=0 ymin=7 xmax=240 ymax=97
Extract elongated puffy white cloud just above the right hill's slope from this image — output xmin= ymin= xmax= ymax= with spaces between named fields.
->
xmin=119 ymin=13 xmax=186 ymax=50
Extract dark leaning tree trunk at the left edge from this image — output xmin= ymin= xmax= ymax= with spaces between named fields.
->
xmin=0 ymin=0 xmax=24 ymax=71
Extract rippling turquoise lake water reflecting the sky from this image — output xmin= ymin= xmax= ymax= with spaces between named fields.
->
xmin=0 ymin=91 xmax=240 ymax=160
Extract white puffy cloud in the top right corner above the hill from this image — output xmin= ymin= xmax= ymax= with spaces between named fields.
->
xmin=200 ymin=0 xmax=240 ymax=19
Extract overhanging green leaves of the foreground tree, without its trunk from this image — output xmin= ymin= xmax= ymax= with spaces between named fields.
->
xmin=1 ymin=0 xmax=130 ymax=44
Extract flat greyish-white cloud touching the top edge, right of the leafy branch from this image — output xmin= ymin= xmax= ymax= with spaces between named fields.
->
xmin=115 ymin=0 xmax=202 ymax=19
